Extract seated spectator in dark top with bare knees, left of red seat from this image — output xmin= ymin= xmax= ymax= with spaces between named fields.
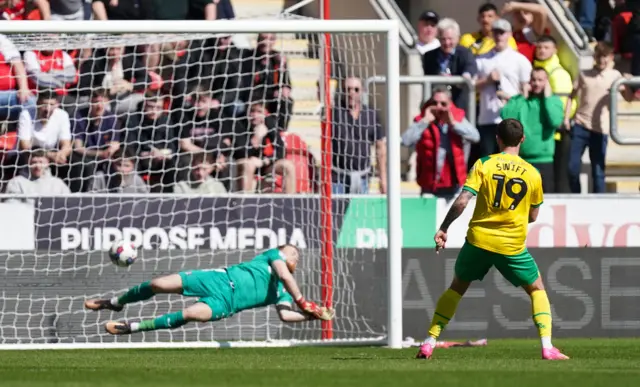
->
xmin=234 ymin=101 xmax=296 ymax=193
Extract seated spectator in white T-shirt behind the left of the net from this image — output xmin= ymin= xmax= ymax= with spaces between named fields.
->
xmin=18 ymin=90 xmax=72 ymax=164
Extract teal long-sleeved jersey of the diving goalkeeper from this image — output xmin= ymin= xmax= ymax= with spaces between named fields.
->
xmin=227 ymin=249 xmax=293 ymax=313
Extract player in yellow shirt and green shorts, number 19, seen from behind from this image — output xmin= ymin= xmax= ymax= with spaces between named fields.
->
xmin=417 ymin=119 xmax=568 ymax=360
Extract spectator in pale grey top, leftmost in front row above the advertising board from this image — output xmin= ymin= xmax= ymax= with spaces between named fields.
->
xmin=5 ymin=149 xmax=70 ymax=200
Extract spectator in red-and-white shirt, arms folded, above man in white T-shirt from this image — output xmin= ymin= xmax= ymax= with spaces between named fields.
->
xmin=24 ymin=50 xmax=76 ymax=95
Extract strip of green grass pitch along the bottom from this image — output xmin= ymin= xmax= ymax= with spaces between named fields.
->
xmin=0 ymin=339 xmax=640 ymax=387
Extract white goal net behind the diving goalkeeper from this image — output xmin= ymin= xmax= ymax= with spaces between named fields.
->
xmin=0 ymin=16 xmax=399 ymax=348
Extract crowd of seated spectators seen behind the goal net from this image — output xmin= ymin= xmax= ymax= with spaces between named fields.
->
xmin=0 ymin=0 xmax=316 ymax=194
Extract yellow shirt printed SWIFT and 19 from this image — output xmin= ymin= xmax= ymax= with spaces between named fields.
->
xmin=463 ymin=153 xmax=543 ymax=255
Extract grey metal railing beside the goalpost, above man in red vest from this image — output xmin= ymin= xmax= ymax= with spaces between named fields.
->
xmin=363 ymin=75 xmax=476 ymax=126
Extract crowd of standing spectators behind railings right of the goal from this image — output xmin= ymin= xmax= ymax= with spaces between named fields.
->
xmin=402 ymin=0 xmax=640 ymax=197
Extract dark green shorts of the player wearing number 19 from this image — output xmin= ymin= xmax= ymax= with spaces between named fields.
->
xmin=454 ymin=242 xmax=540 ymax=286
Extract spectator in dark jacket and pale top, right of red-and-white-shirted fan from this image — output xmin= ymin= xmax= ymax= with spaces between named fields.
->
xmin=78 ymin=47 xmax=151 ymax=114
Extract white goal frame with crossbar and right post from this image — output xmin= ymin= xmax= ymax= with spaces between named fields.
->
xmin=0 ymin=20 xmax=403 ymax=349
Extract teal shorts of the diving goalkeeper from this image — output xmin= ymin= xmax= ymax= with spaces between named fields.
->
xmin=179 ymin=270 xmax=233 ymax=321
